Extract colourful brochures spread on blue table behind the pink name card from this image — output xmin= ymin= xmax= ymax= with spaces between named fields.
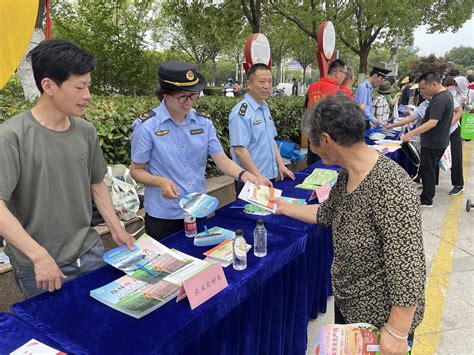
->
xmin=90 ymin=234 xmax=211 ymax=318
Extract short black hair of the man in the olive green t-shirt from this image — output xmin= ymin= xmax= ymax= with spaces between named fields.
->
xmin=28 ymin=39 xmax=96 ymax=93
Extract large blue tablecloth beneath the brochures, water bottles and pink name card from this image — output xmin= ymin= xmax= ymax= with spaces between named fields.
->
xmin=12 ymin=216 xmax=314 ymax=354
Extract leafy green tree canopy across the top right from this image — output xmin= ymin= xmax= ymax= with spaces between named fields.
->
xmin=268 ymin=0 xmax=472 ymax=73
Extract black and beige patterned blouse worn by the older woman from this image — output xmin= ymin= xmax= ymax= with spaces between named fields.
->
xmin=317 ymin=155 xmax=426 ymax=331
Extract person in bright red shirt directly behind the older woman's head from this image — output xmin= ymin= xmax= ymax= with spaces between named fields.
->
xmin=305 ymin=59 xmax=347 ymax=165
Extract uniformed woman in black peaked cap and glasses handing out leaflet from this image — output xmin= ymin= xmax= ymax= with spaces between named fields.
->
xmin=131 ymin=61 xmax=259 ymax=239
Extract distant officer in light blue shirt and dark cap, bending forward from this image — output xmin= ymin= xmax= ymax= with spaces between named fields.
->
xmin=354 ymin=67 xmax=390 ymax=130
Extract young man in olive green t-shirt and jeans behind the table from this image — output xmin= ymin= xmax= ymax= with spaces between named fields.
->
xmin=0 ymin=40 xmax=134 ymax=297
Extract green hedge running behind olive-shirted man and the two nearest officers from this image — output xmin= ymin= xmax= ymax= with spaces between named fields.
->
xmin=0 ymin=87 xmax=304 ymax=176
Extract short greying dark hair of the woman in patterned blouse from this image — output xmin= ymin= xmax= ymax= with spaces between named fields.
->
xmin=301 ymin=95 xmax=365 ymax=147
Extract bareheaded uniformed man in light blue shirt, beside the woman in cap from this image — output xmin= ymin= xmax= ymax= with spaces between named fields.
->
xmin=229 ymin=64 xmax=295 ymax=195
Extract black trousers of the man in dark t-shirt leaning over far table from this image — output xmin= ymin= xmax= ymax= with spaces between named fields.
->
xmin=420 ymin=147 xmax=446 ymax=205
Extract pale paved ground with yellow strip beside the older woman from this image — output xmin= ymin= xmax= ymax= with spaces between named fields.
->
xmin=307 ymin=141 xmax=474 ymax=355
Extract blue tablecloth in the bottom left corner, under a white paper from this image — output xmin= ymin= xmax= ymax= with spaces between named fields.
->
xmin=0 ymin=313 xmax=62 ymax=354
